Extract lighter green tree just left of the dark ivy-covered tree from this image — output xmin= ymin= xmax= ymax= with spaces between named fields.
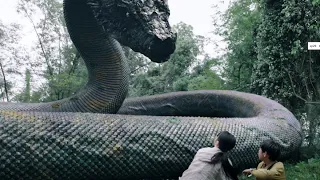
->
xmin=216 ymin=0 xmax=261 ymax=92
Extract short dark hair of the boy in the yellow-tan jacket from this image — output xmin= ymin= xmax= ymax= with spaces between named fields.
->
xmin=260 ymin=139 xmax=280 ymax=161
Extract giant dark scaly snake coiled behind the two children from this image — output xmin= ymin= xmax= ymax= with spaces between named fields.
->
xmin=0 ymin=0 xmax=302 ymax=179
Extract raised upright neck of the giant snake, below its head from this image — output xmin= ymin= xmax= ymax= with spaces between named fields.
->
xmin=50 ymin=0 xmax=129 ymax=113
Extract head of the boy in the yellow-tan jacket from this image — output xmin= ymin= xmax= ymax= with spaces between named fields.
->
xmin=258 ymin=139 xmax=280 ymax=161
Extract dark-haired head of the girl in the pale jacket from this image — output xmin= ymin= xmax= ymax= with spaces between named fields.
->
xmin=214 ymin=131 xmax=236 ymax=152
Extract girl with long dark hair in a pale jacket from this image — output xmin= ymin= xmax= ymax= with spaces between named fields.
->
xmin=179 ymin=131 xmax=238 ymax=180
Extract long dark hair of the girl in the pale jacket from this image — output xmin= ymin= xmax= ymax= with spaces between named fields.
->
xmin=211 ymin=131 xmax=238 ymax=180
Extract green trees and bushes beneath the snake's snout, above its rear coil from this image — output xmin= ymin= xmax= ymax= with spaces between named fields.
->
xmin=129 ymin=23 xmax=222 ymax=96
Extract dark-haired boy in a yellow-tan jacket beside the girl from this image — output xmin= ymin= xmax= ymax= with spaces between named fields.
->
xmin=243 ymin=140 xmax=286 ymax=180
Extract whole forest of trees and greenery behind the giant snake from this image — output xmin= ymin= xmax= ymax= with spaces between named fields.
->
xmin=0 ymin=0 xmax=320 ymax=179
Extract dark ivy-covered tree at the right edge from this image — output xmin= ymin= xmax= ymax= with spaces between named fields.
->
xmin=252 ymin=0 xmax=320 ymax=145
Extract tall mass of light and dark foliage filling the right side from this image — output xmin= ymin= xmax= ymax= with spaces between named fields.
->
xmin=216 ymin=0 xmax=320 ymax=146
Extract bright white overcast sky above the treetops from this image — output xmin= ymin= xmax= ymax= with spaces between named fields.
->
xmin=0 ymin=0 xmax=228 ymax=54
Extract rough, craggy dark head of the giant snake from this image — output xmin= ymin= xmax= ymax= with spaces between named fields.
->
xmin=88 ymin=0 xmax=177 ymax=63
